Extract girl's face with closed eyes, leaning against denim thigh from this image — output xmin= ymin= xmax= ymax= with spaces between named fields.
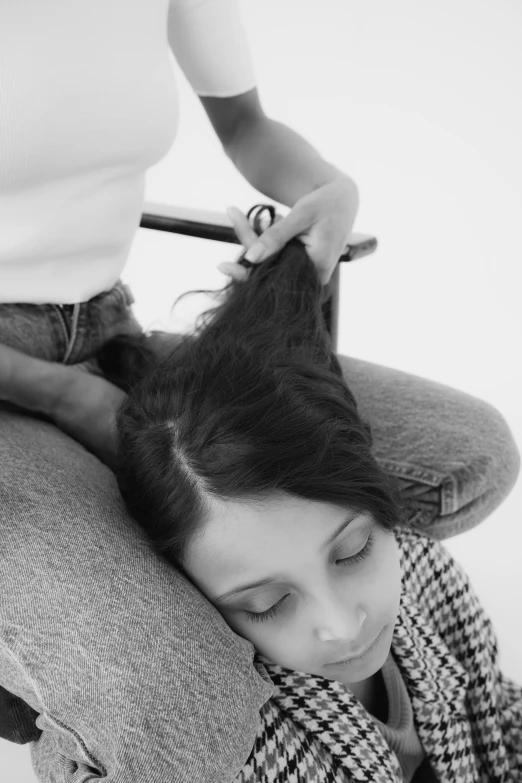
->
xmin=185 ymin=493 xmax=401 ymax=684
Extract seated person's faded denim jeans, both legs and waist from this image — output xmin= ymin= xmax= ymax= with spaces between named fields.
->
xmin=0 ymin=283 xmax=519 ymax=783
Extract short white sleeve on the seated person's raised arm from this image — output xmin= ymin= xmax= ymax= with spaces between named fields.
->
xmin=168 ymin=0 xmax=256 ymax=98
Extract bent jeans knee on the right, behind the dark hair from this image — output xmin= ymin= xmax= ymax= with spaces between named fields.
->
xmin=339 ymin=356 xmax=520 ymax=540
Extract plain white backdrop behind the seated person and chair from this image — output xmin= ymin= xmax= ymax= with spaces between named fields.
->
xmin=0 ymin=0 xmax=522 ymax=783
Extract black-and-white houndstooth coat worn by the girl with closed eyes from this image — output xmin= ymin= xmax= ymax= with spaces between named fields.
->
xmin=235 ymin=528 xmax=522 ymax=783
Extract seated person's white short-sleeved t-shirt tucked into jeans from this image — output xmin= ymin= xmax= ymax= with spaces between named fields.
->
xmin=0 ymin=0 xmax=256 ymax=304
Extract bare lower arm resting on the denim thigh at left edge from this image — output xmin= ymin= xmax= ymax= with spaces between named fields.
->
xmin=0 ymin=344 xmax=126 ymax=468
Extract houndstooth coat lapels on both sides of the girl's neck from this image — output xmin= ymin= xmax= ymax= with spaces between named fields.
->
xmin=256 ymin=552 xmax=481 ymax=783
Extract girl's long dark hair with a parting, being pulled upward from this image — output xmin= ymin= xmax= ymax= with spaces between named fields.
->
xmin=98 ymin=240 xmax=406 ymax=573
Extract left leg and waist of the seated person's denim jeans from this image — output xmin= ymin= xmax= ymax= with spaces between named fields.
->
xmin=0 ymin=296 xmax=273 ymax=783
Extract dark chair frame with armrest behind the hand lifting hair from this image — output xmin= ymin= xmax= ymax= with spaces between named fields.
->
xmin=140 ymin=201 xmax=377 ymax=351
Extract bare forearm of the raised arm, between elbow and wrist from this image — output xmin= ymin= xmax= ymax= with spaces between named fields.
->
xmin=225 ymin=117 xmax=358 ymax=207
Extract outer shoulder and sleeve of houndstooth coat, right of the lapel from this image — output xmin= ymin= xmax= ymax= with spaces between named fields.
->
xmin=406 ymin=539 xmax=522 ymax=783
